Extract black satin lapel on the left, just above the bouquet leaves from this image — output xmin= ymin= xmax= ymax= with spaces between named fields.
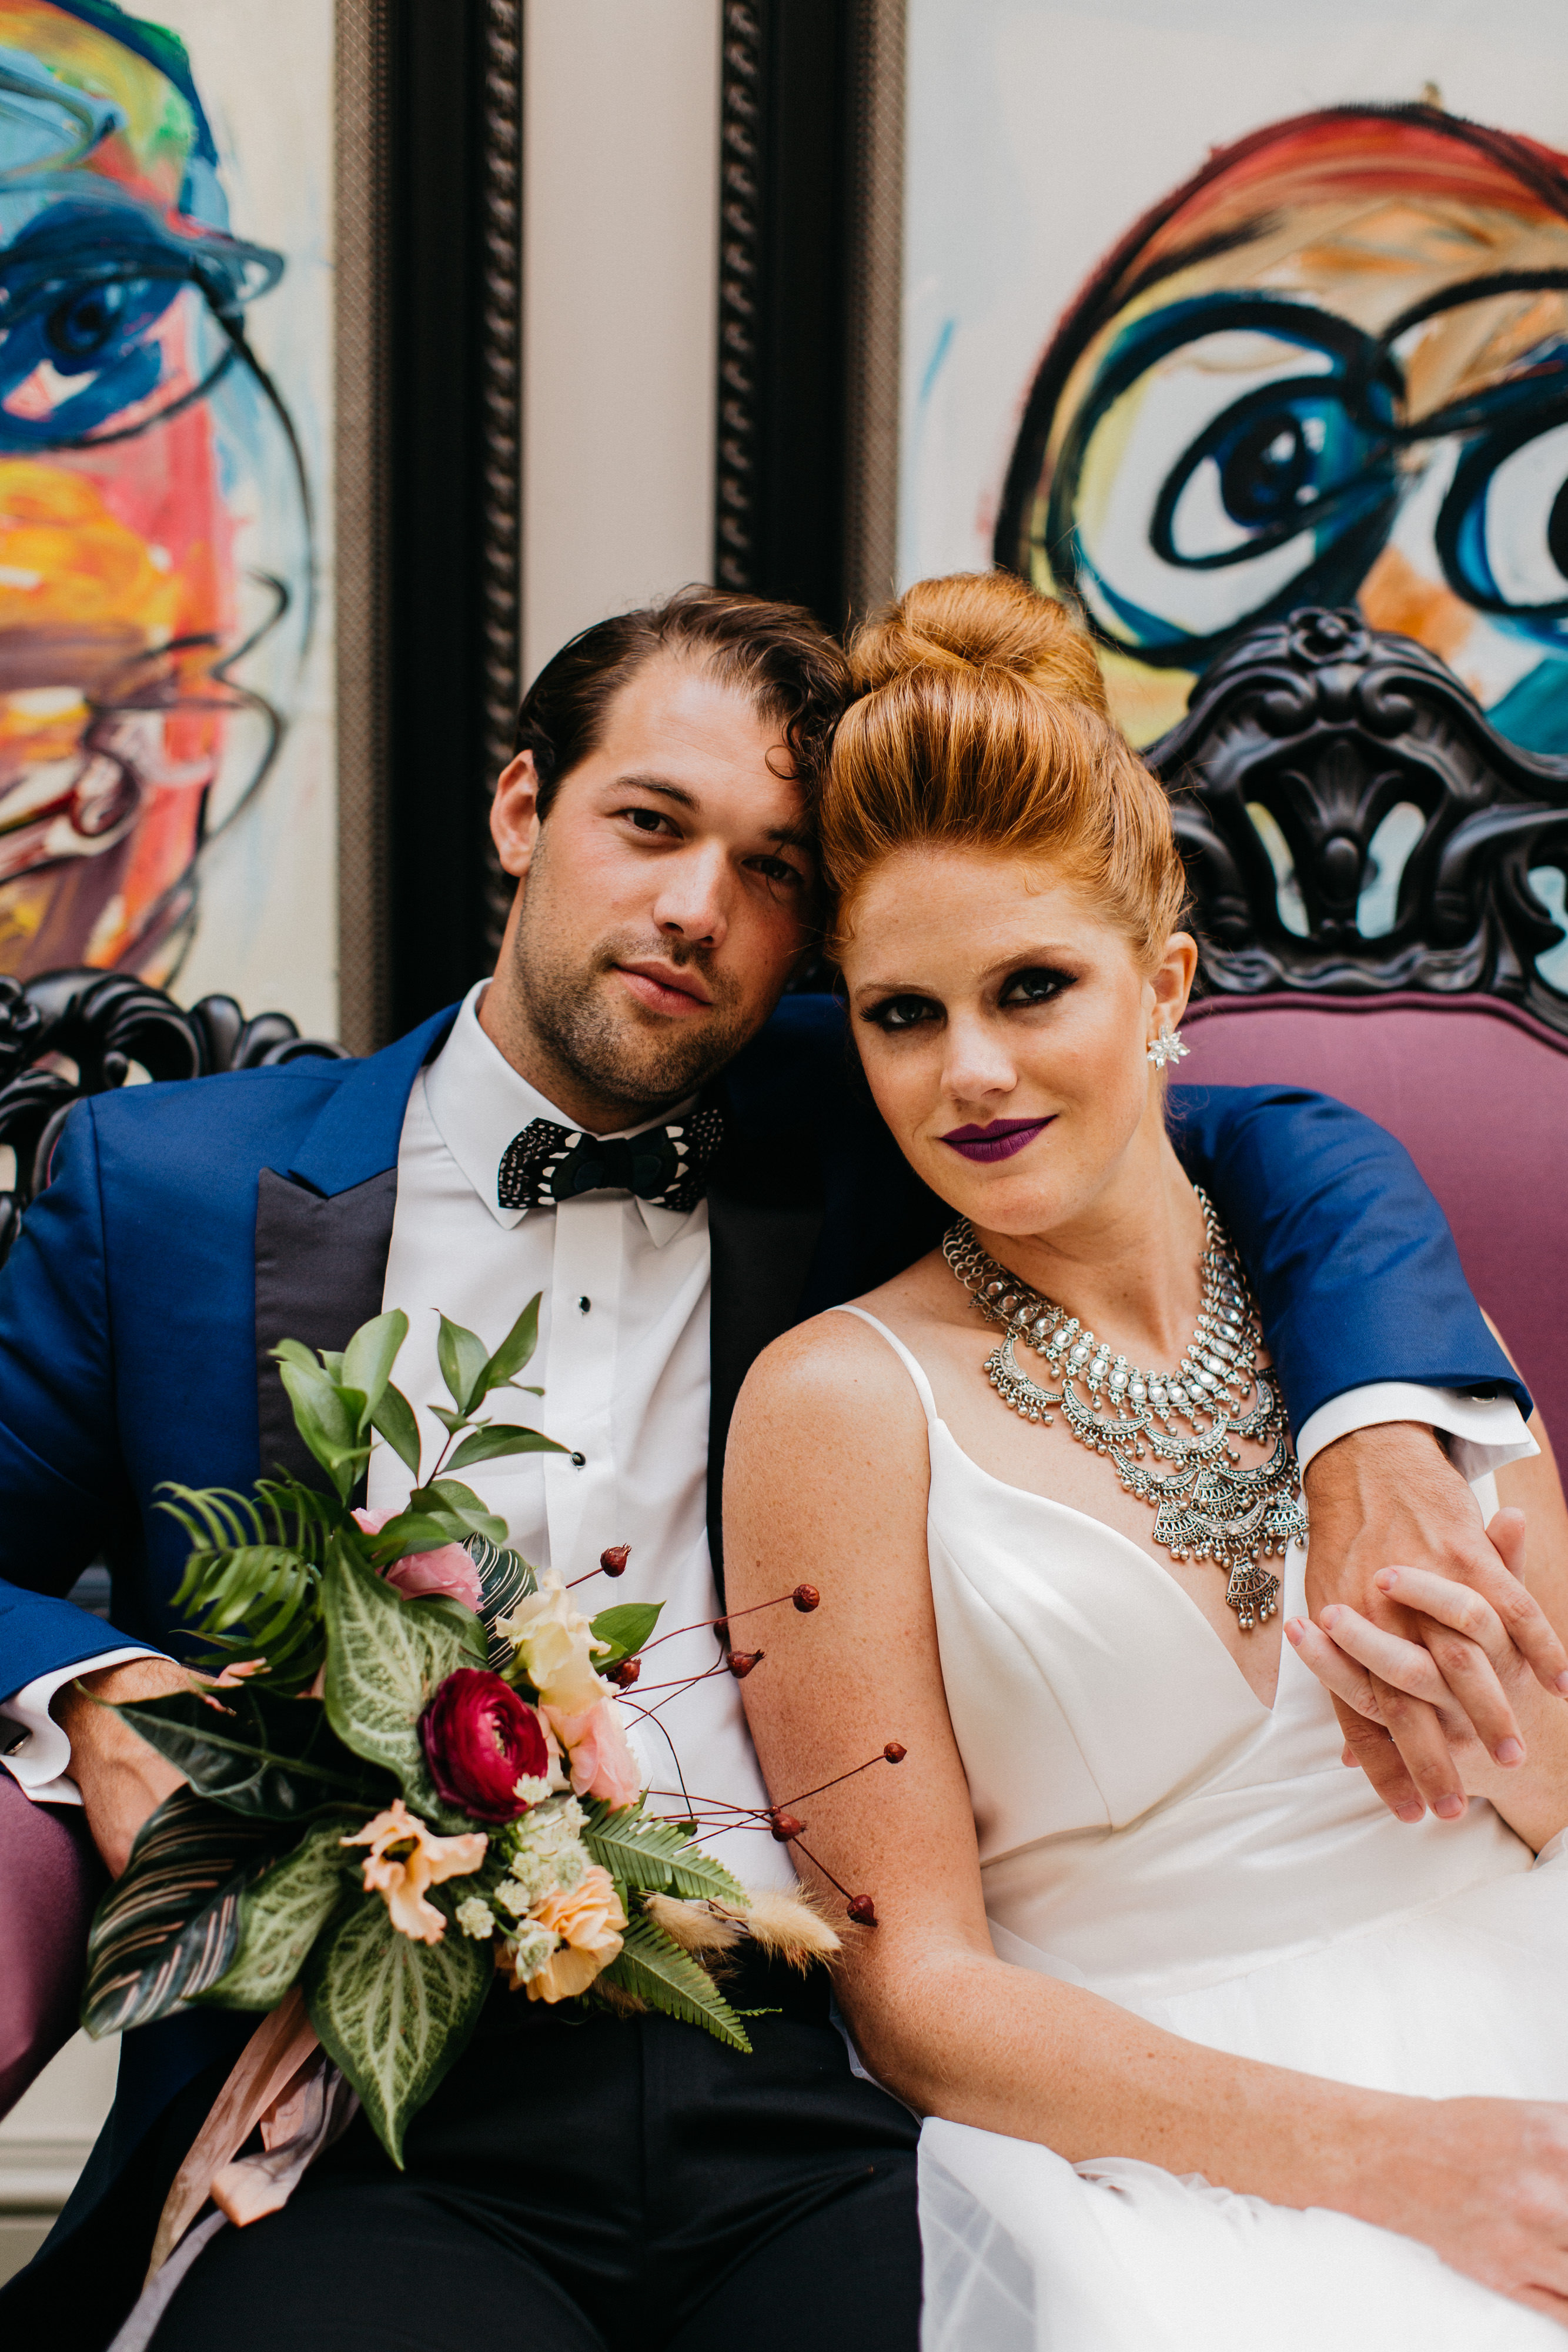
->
xmin=256 ymin=1169 xmax=397 ymax=1486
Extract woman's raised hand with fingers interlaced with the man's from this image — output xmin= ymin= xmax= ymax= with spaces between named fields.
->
xmin=1286 ymin=1510 xmax=1568 ymax=1849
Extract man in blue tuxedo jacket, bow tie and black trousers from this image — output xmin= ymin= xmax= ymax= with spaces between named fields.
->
xmin=0 ymin=590 xmax=1568 ymax=2352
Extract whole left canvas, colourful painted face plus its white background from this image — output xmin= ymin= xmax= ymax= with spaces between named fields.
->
xmin=0 ymin=0 xmax=336 ymax=1033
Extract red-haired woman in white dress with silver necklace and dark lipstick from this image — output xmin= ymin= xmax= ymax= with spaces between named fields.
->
xmin=727 ymin=581 xmax=1568 ymax=2352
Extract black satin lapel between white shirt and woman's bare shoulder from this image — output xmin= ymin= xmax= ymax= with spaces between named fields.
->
xmin=708 ymin=1157 xmax=823 ymax=1604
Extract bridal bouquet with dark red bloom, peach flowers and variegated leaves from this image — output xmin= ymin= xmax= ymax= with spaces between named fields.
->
xmin=82 ymin=1298 xmax=851 ymax=2161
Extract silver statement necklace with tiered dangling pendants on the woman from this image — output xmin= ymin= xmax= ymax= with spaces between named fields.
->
xmin=942 ymin=1188 xmax=1307 ymax=1632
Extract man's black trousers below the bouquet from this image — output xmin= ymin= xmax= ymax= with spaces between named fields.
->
xmin=153 ymin=1966 xmax=919 ymax=2352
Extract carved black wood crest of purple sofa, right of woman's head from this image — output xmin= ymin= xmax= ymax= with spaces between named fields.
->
xmin=1149 ymin=609 xmax=1568 ymax=1035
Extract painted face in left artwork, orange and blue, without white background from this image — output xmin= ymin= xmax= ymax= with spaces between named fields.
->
xmin=0 ymin=0 xmax=310 ymax=981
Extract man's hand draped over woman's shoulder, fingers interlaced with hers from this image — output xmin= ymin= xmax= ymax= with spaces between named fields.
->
xmin=1305 ymin=1421 xmax=1568 ymax=1820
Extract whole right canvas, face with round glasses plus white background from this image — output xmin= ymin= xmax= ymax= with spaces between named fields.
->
xmin=898 ymin=0 xmax=1568 ymax=753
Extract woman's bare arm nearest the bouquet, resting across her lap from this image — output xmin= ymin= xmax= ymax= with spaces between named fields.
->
xmin=727 ymin=1315 xmax=1568 ymax=2317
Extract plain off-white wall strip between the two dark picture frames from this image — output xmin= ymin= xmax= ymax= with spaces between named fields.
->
xmin=522 ymin=0 xmax=720 ymax=677
